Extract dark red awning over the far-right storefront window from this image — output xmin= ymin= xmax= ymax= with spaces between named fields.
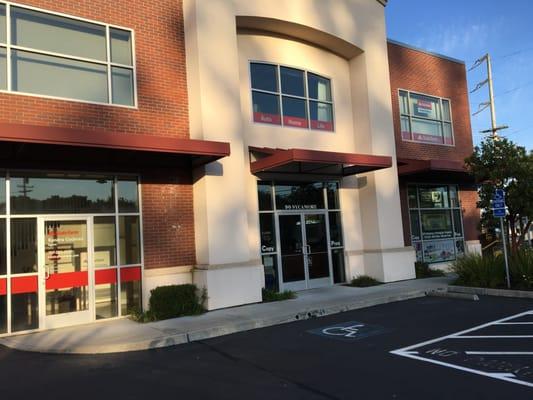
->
xmin=398 ymin=158 xmax=474 ymax=183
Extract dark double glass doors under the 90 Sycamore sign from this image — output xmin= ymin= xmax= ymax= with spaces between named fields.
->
xmin=278 ymin=212 xmax=333 ymax=290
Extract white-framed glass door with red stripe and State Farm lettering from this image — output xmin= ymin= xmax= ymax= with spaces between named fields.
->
xmin=38 ymin=217 xmax=93 ymax=328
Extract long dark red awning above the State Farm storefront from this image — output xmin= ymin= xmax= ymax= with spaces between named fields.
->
xmin=0 ymin=123 xmax=230 ymax=167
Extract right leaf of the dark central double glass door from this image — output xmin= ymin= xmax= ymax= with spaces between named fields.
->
xmin=303 ymin=213 xmax=333 ymax=289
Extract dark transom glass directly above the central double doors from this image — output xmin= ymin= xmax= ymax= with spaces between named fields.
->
xmin=276 ymin=183 xmax=325 ymax=210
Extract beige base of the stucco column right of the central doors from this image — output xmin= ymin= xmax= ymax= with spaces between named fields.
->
xmin=347 ymin=246 xmax=416 ymax=282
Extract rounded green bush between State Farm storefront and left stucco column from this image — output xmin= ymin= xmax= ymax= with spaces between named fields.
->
xmin=149 ymin=284 xmax=206 ymax=320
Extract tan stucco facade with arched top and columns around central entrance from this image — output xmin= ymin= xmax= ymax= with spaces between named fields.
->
xmin=184 ymin=0 xmax=410 ymax=304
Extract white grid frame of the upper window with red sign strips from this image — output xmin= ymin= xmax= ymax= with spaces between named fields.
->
xmin=248 ymin=60 xmax=337 ymax=133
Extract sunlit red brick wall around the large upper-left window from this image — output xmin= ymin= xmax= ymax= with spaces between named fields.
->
xmin=0 ymin=0 xmax=189 ymax=137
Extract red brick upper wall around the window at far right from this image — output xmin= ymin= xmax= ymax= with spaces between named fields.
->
xmin=388 ymin=43 xmax=472 ymax=161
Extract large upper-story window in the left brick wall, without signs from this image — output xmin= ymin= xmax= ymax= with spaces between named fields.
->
xmin=0 ymin=2 xmax=136 ymax=106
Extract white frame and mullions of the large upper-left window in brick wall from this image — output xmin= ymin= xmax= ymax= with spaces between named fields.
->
xmin=0 ymin=0 xmax=139 ymax=109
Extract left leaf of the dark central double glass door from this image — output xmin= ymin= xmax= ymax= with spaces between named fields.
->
xmin=279 ymin=214 xmax=307 ymax=290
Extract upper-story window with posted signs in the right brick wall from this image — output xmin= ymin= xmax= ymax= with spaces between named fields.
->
xmin=399 ymin=90 xmax=454 ymax=146
